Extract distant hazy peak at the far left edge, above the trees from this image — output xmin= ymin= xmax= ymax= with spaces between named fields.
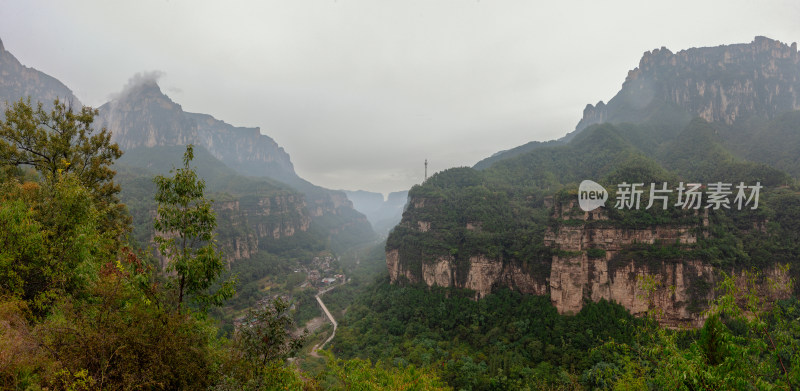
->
xmin=0 ymin=36 xmax=81 ymax=108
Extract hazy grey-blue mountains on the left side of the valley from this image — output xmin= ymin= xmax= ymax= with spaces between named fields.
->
xmin=0 ymin=36 xmax=376 ymax=261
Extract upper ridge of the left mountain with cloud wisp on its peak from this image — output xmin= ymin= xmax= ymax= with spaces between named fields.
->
xmin=97 ymin=81 xmax=375 ymax=249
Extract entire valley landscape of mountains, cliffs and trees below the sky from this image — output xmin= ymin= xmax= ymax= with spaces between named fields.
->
xmin=0 ymin=25 xmax=800 ymax=390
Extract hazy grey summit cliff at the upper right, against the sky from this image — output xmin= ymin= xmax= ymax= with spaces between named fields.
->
xmin=576 ymin=37 xmax=800 ymax=131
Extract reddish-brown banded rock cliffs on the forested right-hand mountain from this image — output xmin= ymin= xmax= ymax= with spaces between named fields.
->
xmin=386 ymin=195 xmax=790 ymax=327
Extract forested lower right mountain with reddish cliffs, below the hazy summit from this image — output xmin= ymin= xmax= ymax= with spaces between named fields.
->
xmin=386 ymin=119 xmax=800 ymax=326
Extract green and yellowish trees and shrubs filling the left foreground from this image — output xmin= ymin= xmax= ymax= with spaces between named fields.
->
xmin=0 ymin=101 xmax=444 ymax=390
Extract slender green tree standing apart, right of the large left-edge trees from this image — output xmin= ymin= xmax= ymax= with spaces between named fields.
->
xmin=153 ymin=144 xmax=235 ymax=311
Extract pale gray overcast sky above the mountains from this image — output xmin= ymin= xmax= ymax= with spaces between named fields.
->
xmin=0 ymin=0 xmax=800 ymax=193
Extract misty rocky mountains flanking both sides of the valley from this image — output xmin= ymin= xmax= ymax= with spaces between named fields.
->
xmin=0 ymin=33 xmax=800 ymax=326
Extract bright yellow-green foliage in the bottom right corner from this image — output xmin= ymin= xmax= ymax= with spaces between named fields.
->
xmin=615 ymin=266 xmax=800 ymax=390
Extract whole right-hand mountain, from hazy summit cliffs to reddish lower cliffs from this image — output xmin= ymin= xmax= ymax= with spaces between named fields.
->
xmin=386 ymin=37 xmax=800 ymax=326
